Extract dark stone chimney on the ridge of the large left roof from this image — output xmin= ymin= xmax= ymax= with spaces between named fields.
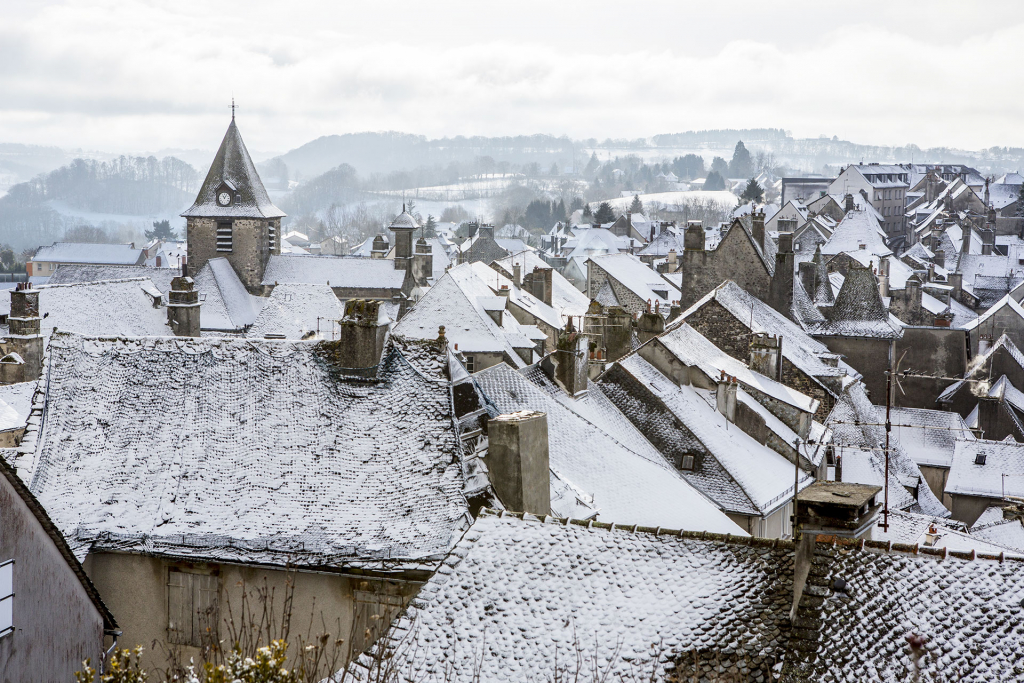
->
xmin=317 ymin=299 xmax=388 ymax=377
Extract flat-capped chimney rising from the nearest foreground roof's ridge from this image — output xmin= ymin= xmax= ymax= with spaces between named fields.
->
xmin=790 ymin=481 xmax=882 ymax=622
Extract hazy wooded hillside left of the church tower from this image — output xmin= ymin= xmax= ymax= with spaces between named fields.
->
xmin=0 ymin=157 xmax=199 ymax=250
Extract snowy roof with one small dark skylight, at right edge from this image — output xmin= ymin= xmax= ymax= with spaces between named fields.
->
xmin=946 ymin=439 xmax=1024 ymax=499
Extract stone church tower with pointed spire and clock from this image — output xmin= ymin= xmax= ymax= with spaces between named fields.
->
xmin=181 ymin=111 xmax=285 ymax=294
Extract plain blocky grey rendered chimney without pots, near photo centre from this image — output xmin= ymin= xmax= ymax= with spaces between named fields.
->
xmin=484 ymin=411 xmax=551 ymax=516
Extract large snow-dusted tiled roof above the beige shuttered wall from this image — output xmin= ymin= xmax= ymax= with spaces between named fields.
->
xmin=18 ymin=334 xmax=467 ymax=569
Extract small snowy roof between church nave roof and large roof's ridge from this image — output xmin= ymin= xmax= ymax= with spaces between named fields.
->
xmin=246 ymin=284 xmax=345 ymax=339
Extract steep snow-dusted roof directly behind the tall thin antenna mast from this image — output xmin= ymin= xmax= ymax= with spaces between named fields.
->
xmin=825 ymin=382 xmax=949 ymax=517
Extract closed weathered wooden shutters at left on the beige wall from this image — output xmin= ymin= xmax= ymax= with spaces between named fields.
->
xmin=167 ymin=569 xmax=219 ymax=647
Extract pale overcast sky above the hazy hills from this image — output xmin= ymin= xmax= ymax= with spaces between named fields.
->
xmin=0 ymin=0 xmax=1024 ymax=152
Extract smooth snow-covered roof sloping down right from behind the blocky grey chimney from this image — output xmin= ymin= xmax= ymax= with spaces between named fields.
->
xmin=474 ymin=364 xmax=744 ymax=535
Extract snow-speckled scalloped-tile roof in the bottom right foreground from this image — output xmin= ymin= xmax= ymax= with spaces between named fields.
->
xmin=349 ymin=512 xmax=1024 ymax=683
